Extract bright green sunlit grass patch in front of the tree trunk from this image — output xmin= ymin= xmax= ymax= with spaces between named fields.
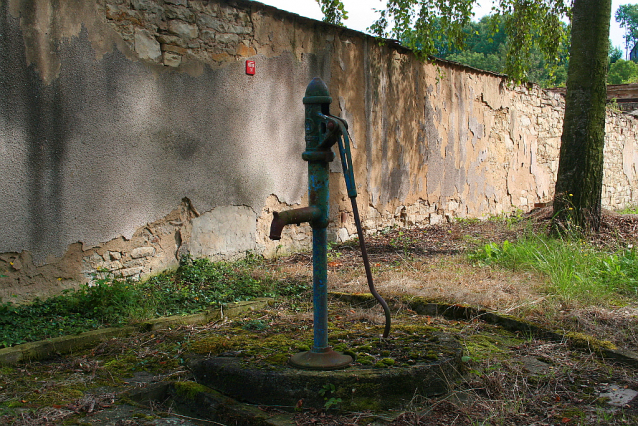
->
xmin=469 ymin=234 xmax=638 ymax=304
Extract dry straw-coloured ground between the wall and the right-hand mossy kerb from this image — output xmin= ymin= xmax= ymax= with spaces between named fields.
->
xmin=320 ymin=208 xmax=638 ymax=352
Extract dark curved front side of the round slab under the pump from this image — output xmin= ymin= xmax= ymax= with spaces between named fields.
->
xmin=190 ymin=338 xmax=462 ymax=411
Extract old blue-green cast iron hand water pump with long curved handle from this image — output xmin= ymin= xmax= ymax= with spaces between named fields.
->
xmin=270 ymin=78 xmax=390 ymax=370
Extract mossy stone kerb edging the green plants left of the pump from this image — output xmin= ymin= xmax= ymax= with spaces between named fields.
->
xmin=0 ymin=297 xmax=272 ymax=365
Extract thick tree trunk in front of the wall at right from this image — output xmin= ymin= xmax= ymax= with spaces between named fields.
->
xmin=553 ymin=0 xmax=611 ymax=231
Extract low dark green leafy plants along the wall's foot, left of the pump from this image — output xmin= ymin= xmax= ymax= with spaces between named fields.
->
xmin=0 ymin=257 xmax=308 ymax=347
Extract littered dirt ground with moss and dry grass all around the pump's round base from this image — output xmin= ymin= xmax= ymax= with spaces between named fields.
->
xmin=0 ymin=210 xmax=638 ymax=426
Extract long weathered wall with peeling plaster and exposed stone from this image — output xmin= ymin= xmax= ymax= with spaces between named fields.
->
xmin=0 ymin=0 xmax=638 ymax=300
